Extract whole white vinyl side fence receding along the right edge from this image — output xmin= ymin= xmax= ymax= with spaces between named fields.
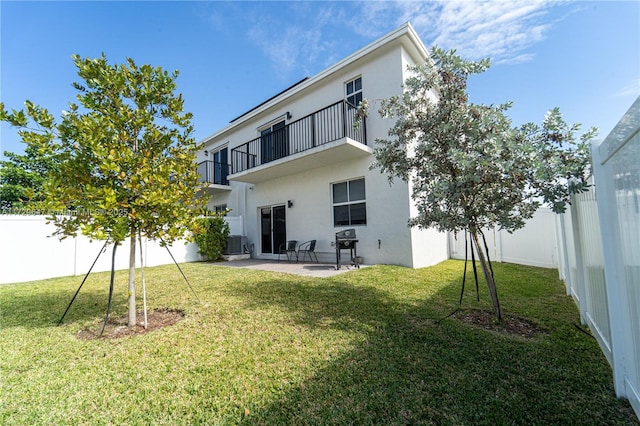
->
xmin=558 ymin=97 xmax=640 ymax=415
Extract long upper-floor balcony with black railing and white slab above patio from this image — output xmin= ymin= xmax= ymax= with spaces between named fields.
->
xmin=229 ymin=101 xmax=373 ymax=183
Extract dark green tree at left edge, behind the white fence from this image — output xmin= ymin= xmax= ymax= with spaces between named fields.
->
xmin=0 ymin=146 xmax=55 ymax=210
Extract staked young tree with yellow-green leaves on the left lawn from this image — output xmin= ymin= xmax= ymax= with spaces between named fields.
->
xmin=0 ymin=54 xmax=205 ymax=326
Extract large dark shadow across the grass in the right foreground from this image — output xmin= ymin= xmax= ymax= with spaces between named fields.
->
xmin=222 ymin=276 xmax=635 ymax=425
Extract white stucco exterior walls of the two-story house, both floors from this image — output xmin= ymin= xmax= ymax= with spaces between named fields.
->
xmin=201 ymin=26 xmax=448 ymax=267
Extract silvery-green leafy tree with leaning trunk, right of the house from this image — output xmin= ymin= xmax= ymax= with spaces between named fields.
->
xmin=368 ymin=47 xmax=596 ymax=319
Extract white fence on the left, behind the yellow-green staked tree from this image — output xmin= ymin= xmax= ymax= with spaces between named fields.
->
xmin=0 ymin=215 xmax=243 ymax=284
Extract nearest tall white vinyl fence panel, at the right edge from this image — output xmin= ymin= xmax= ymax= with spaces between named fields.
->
xmin=592 ymin=97 xmax=640 ymax=413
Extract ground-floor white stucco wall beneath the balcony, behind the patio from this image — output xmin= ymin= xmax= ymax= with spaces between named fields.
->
xmin=240 ymin=151 xmax=420 ymax=266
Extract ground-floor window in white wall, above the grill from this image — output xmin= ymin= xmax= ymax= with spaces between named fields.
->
xmin=331 ymin=179 xmax=367 ymax=226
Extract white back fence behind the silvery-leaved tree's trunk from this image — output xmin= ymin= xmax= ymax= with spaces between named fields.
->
xmin=449 ymin=208 xmax=558 ymax=268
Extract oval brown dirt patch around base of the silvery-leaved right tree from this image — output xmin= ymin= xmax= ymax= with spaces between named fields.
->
xmin=453 ymin=309 xmax=546 ymax=339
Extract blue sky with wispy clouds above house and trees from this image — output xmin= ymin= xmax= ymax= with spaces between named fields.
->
xmin=0 ymin=0 xmax=640 ymax=158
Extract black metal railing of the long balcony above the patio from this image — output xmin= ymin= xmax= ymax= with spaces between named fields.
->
xmin=231 ymin=100 xmax=367 ymax=173
